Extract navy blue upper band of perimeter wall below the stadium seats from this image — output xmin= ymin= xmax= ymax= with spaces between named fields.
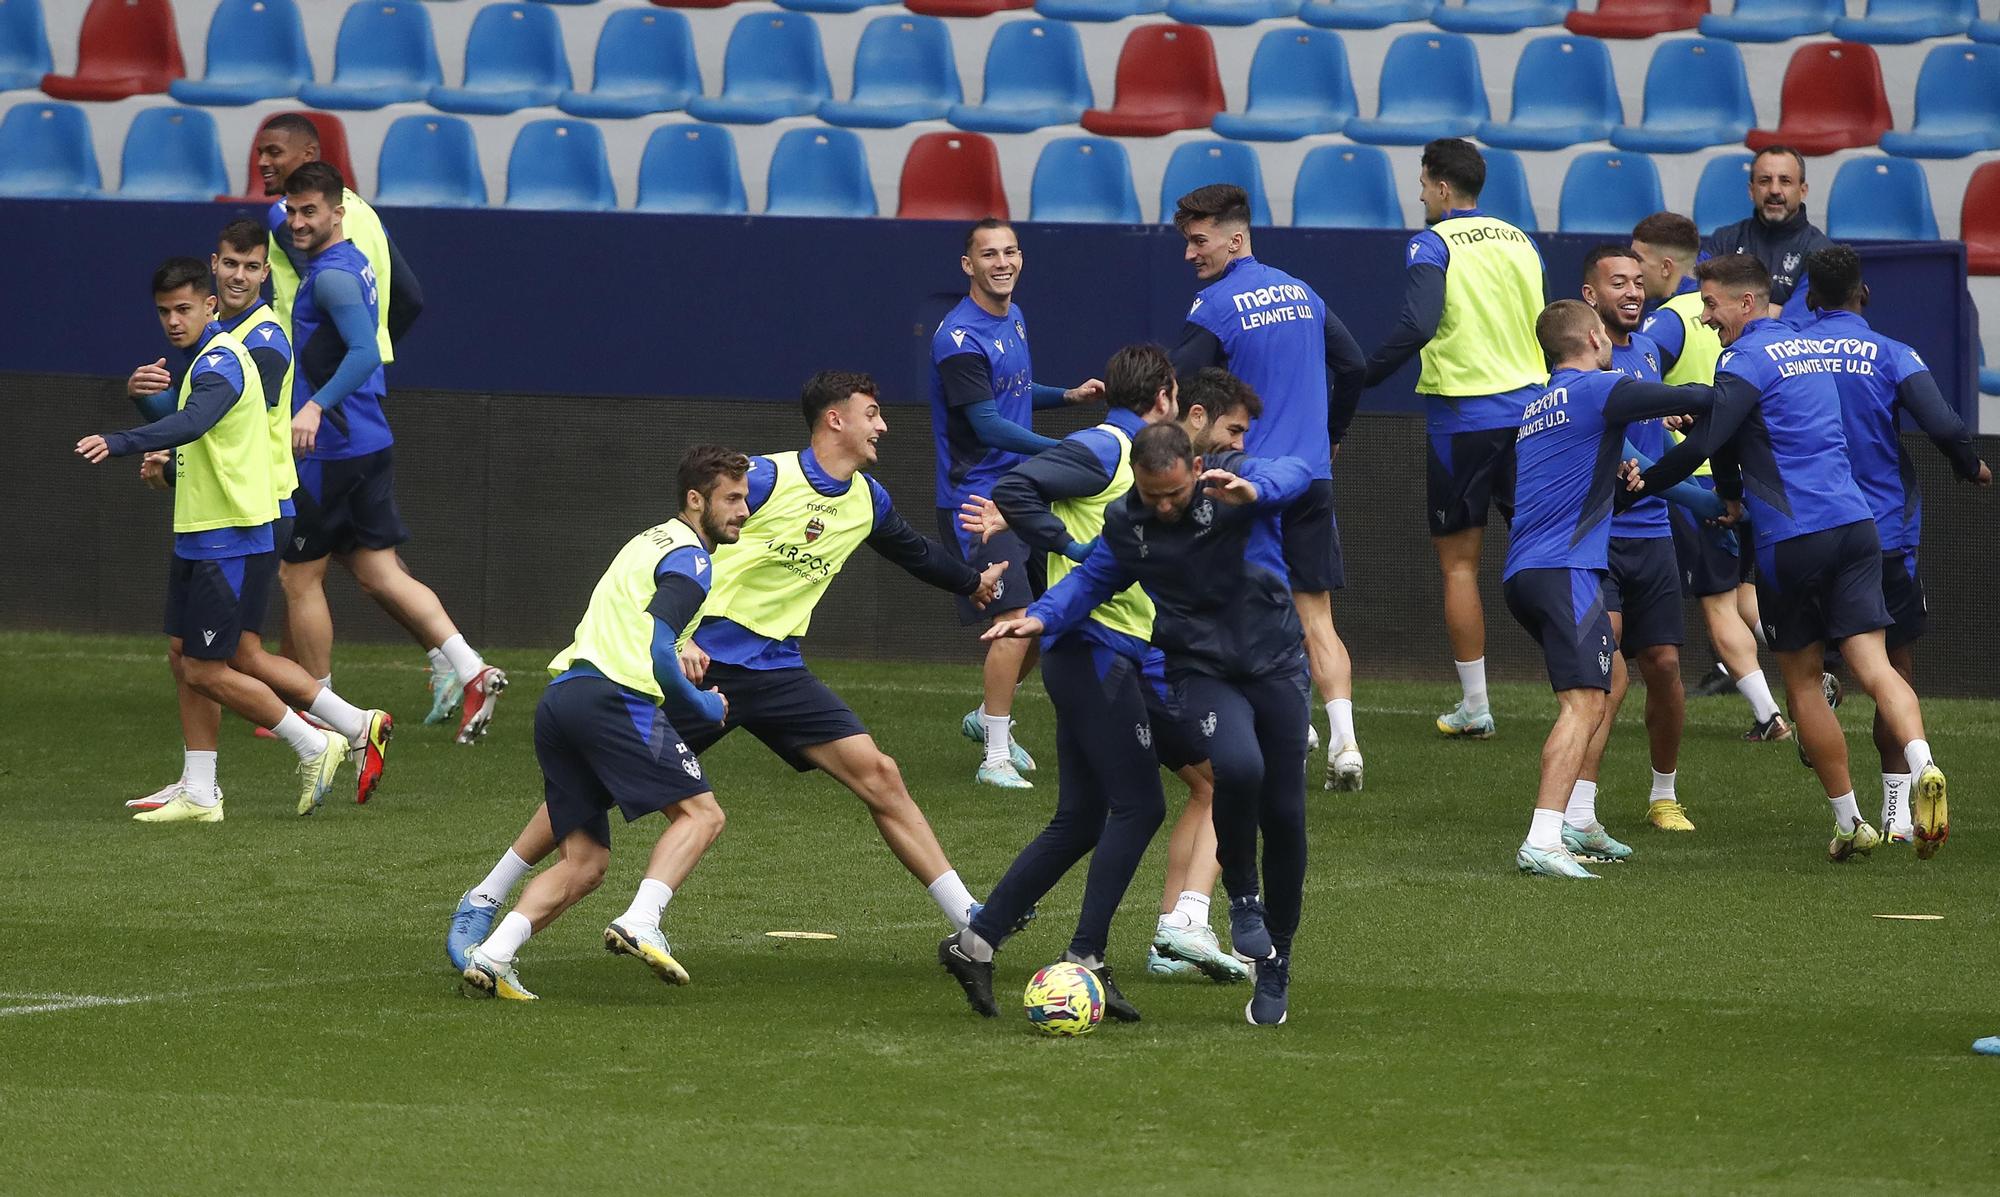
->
xmin=0 ymin=200 xmax=1978 ymax=426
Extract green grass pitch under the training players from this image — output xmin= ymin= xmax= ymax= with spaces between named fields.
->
xmin=0 ymin=631 xmax=2000 ymax=1195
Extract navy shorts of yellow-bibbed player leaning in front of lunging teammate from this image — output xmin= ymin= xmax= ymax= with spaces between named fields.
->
xmin=534 ymin=677 xmax=712 ymax=847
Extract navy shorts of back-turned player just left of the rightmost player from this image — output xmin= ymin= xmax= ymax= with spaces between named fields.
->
xmin=1756 ymin=520 xmax=1890 ymax=653
